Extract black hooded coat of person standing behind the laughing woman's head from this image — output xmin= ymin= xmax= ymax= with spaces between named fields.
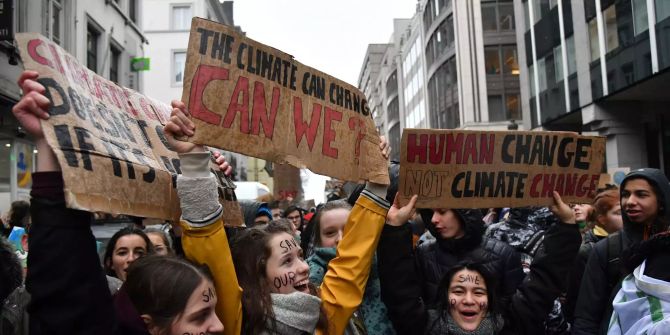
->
xmin=414 ymin=209 xmax=525 ymax=306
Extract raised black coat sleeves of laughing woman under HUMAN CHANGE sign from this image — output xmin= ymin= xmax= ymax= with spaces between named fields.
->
xmin=377 ymin=223 xmax=581 ymax=334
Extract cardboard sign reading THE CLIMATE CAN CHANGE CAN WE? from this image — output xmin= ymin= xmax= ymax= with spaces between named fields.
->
xmin=182 ymin=18 xmax=388 ymax=183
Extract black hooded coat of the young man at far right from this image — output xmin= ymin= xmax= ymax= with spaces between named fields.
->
xmin=572 ymin=168 xmax=670 ymax=335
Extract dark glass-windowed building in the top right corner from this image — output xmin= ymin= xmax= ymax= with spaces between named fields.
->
xmin=515 ymin=0 xmax=670 ymax=174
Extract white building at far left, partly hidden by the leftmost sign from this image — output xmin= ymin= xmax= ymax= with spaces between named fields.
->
xmin=0 ymin=0 xmax=147 ymax=212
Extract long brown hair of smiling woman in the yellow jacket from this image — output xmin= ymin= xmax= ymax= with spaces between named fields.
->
xmin=231 ymin=221 xmax=328 ymax=334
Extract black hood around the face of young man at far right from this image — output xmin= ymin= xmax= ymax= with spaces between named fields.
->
xmin=620 ymin=168 xmax=670 ymax=242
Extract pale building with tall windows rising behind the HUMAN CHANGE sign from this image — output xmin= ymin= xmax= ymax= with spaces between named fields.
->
xmin=359 ymin=0 xmax=524 ymax=158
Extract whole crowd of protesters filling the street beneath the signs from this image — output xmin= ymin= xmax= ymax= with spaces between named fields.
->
xmin=0 ymin=71 xmax=670 ymax=335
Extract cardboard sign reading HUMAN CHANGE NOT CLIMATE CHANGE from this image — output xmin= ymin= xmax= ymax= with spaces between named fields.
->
xmin=399 ymin=129 xmax=605 ymax=208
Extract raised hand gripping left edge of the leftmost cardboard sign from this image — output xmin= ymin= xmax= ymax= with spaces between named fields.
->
xmin=12 ymin=71 xmax=51 ymax=140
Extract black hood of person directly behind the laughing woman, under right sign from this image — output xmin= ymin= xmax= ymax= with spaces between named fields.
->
xmin=419 ymin=209 xmax=486 ymax=253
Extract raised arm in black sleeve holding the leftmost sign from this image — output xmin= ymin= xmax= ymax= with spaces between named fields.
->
xmin=12 ymin=71 xmax=116 ymax=334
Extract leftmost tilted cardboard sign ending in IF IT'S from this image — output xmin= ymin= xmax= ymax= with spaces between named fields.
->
xmin=16 ymin=33 xmax=179 ymax=219
